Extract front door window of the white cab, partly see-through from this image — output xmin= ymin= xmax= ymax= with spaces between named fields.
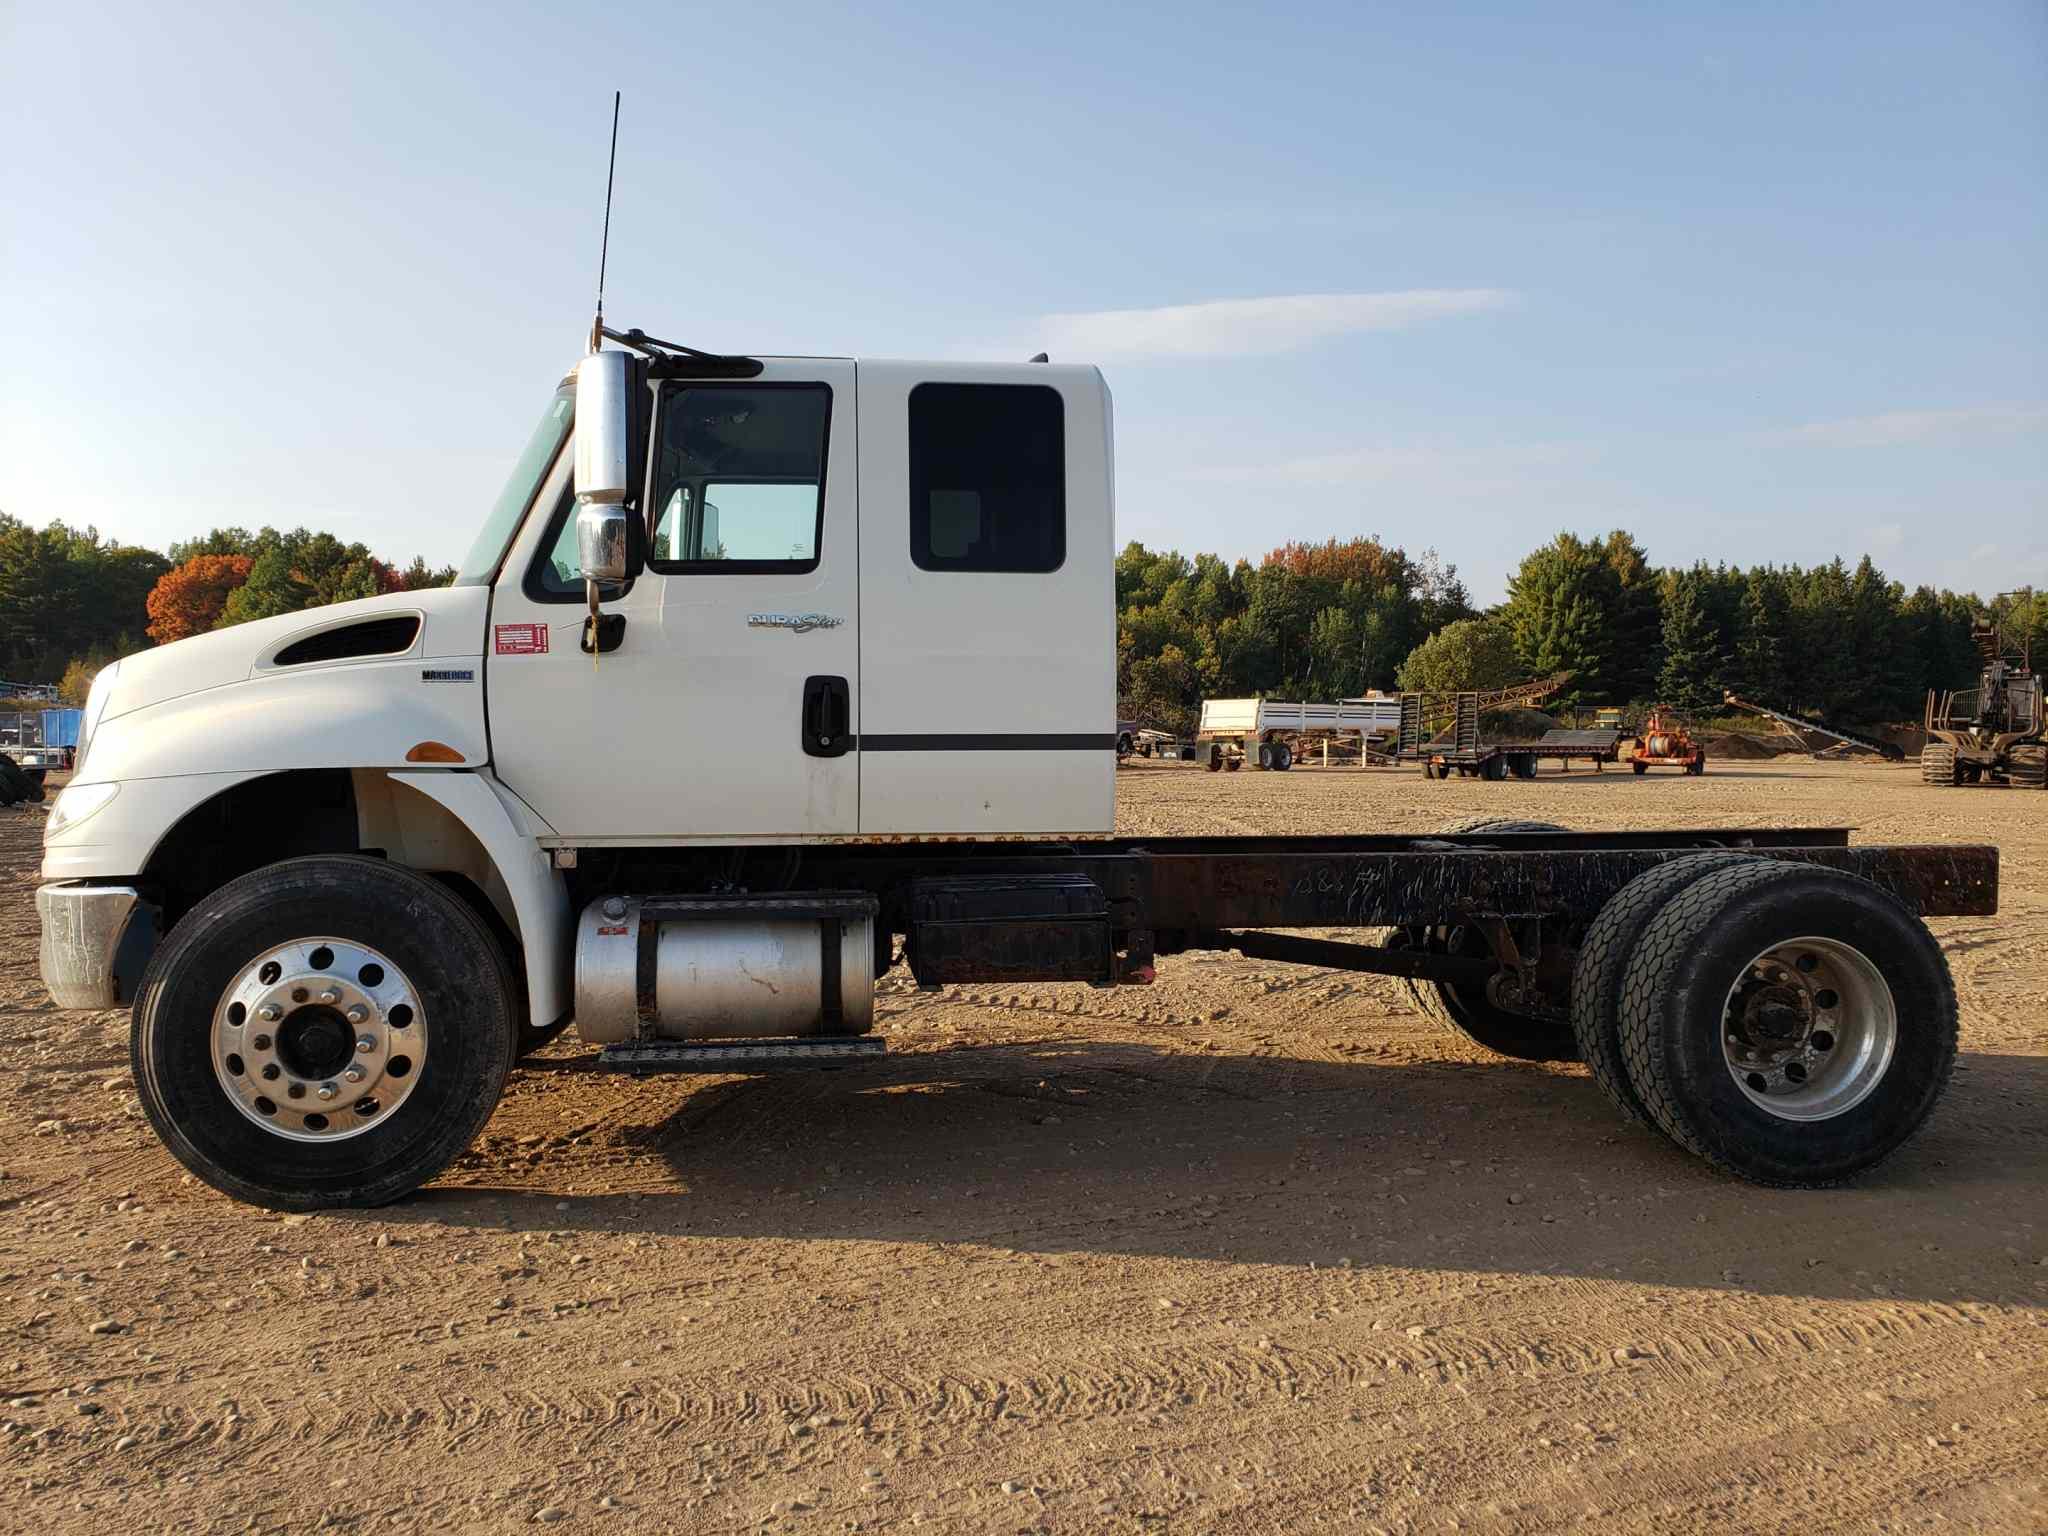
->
xmin=647 ymin=385 xmax=831 ymax=575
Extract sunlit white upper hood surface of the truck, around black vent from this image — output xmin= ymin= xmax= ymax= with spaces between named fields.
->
xmin=102 ymin=586 xmax=489 ymax=721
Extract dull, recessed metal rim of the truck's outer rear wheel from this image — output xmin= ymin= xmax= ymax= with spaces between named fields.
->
xmin=1720 ymin=938 xmax=1898 ymax=1120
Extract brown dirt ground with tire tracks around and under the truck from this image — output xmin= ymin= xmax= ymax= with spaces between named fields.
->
xmin=0 ymin=760 xmax=2048 ymax=1534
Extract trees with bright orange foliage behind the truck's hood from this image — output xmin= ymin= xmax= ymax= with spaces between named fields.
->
xmin=0 ymin=512 xmax=455 ymax=705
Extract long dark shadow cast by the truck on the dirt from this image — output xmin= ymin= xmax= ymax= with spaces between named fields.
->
xmin=387 ymin=1038 xmax=2048 ymax=1307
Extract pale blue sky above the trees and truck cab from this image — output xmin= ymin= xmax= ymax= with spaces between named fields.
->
xmin=0 ymin=0 xmax=2048 ymax=600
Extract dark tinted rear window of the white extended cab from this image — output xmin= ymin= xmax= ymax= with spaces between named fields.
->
xmin=909 ymin=383 xmax=1067 ymax=571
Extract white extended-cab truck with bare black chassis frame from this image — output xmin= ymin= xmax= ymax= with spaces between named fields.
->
xmin=37 ymin=326 xmax=1997 ymax=1210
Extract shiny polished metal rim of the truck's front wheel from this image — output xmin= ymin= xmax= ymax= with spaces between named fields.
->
xmin=213 ymin=938 xmax=428 ymax=1141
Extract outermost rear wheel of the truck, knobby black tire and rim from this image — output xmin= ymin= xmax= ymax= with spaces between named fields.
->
xmin=1618 ymin=860 xmax=1956 ymax=1186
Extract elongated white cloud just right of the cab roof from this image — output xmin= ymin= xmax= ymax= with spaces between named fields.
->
xmin=1038 ymin=289 xmax=1513 ymax=362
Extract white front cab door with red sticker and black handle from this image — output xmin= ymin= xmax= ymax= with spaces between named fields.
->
xmin=487 ymin=358 xmax=860 ymax=844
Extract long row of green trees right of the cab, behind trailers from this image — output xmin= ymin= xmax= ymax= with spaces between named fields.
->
xmin=1116 ymin=530 xmax=2048 ymax=731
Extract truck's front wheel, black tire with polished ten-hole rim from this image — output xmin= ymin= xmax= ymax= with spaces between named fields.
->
xmin=129 ymin=856 xmax=518 ymax=1210
